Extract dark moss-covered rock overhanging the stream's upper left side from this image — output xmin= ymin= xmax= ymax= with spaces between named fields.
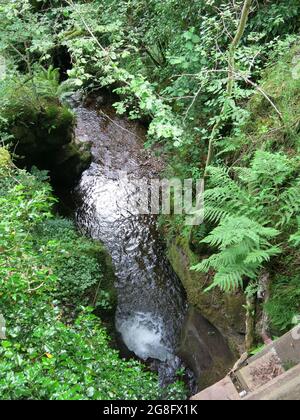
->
xmin=0 ymin=74 xmax=91 ymax=188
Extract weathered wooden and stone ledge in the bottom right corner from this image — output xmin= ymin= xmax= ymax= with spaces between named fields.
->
xmin=192 ymin=326 xmax=300 ymax=401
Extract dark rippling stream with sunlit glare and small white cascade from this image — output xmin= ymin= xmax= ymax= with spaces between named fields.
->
xmin=76 ymin=101 xmax=186 ymax=382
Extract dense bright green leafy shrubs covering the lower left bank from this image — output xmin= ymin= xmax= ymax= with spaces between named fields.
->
xmin=0 ymin=167 xmax=184 ymax=400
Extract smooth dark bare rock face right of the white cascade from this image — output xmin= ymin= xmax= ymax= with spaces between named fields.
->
xmin=178 ymin=307 xmax=235 ymax=390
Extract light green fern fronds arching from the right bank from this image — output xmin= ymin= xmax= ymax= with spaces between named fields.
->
xmin=193 ymin=151 xmax=300 ymax=291
